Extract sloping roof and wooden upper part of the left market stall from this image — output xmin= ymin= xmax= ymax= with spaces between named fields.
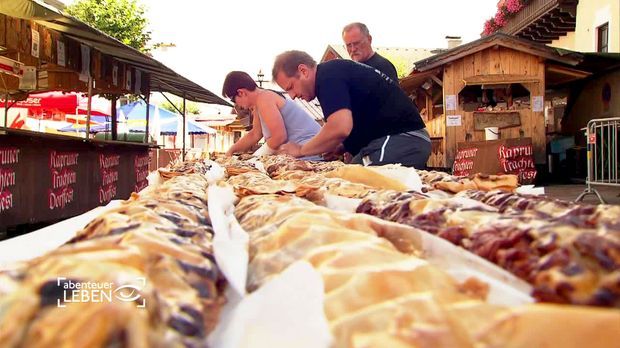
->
xmin=0 ymin=0 xmax=229 ymax=140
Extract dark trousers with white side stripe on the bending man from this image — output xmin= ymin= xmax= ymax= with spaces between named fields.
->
xmin=351 ymin=129 xmax=431 ymax=169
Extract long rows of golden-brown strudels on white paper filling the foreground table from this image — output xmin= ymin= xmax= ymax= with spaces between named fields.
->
xmin=0 ymin=156 xmax=620 ymax=347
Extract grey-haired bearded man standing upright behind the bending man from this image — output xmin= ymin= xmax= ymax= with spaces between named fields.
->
xmin=342 ymin=22 xmax=398 ymax=82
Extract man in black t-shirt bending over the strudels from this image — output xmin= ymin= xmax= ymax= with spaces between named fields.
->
xmin=272 ymin=51 xmax=431 ymax=169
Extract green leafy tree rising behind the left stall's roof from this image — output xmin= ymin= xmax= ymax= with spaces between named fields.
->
xmin=65 ymin=0 xmax=157 ymax=53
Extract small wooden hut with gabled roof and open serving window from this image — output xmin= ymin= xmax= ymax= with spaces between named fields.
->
xmin=400 ymin=33 xmax=590 ymax=168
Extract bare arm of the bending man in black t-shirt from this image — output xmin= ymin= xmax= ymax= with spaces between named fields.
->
xmin=280 ymin=109 xmax=353 ymax=157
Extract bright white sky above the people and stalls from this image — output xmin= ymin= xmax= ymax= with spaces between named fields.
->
xmin=63 ymin=0 xmax=498 ymax=110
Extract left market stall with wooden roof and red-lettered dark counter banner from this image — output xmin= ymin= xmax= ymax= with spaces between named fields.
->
xmin=0 ymin=0 xmax=229 ymax=231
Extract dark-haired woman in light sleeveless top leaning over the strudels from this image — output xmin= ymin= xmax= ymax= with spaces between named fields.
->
xmin=222 ymin=71 xmax=321 ymax=160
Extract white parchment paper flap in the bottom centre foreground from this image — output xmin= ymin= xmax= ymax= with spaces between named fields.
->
xmin=208 ymin=261 xmax=332 ymax=348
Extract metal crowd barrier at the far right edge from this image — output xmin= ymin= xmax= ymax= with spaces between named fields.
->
xmin=575 ymin=117 xmax=620 ymax=203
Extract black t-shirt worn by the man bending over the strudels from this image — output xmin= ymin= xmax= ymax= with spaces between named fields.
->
xmin=315 ymin=59 xmax=425 ymax=155
